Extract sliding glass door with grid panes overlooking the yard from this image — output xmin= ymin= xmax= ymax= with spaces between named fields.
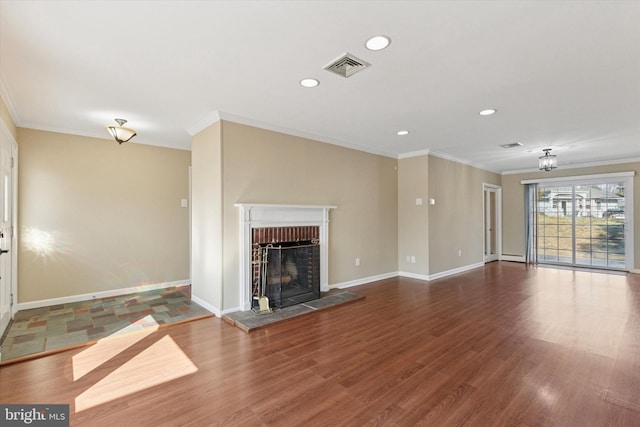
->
xmin=529 ymin=179 xmax=633 ymax=270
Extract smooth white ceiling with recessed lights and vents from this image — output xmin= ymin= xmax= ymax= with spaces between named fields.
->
xmin=0 ymin=0 xmax=640 ymax=172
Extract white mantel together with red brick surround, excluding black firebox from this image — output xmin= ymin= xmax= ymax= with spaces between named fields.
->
xmin=235 ymin=203 xmax=336 ymax=311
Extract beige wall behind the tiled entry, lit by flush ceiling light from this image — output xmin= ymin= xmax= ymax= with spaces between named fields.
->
xmin=18 ymin=128 xmax=190 ymax=302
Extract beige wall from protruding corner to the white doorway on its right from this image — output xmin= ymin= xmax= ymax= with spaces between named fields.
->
xmin=429 ymin=156 xmax=501 ymax=275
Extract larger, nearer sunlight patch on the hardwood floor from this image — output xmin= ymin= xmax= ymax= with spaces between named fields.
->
xmin=75 ymin=335 xmax=198 ymax=413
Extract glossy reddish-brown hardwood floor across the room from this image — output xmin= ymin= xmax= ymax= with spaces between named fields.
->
xmin=0 ymin=262 xmax=640 ymax=426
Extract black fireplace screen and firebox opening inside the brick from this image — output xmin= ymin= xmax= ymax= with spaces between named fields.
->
xmin=258 ymin=241 xmax=320 ymax=308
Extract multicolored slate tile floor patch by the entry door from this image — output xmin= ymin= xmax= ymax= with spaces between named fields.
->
xmin=0 ymin=286 xmax=213 ymax=363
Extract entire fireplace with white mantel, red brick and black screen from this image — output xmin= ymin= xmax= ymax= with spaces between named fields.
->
xmin=236 ymin=203 xmax=335 ymax=311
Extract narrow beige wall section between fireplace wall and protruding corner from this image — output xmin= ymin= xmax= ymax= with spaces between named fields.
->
xmin=398 ymin=155 xmax=429 ymax=276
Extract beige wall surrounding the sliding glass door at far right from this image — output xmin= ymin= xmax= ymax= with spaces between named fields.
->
xmin=502 ymin=162 xmax=640 ymax=270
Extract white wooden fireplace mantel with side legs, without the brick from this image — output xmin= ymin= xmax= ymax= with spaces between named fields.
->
xmin=235 ymin=203 xmax=337 ymax=311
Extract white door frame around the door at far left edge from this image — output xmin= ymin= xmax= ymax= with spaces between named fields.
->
xmin=0 ymin=120 xmax=18 ymax=334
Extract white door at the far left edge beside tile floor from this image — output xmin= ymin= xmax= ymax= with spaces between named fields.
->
xmin=0 ymin=133 xmax=14 ymax=335
